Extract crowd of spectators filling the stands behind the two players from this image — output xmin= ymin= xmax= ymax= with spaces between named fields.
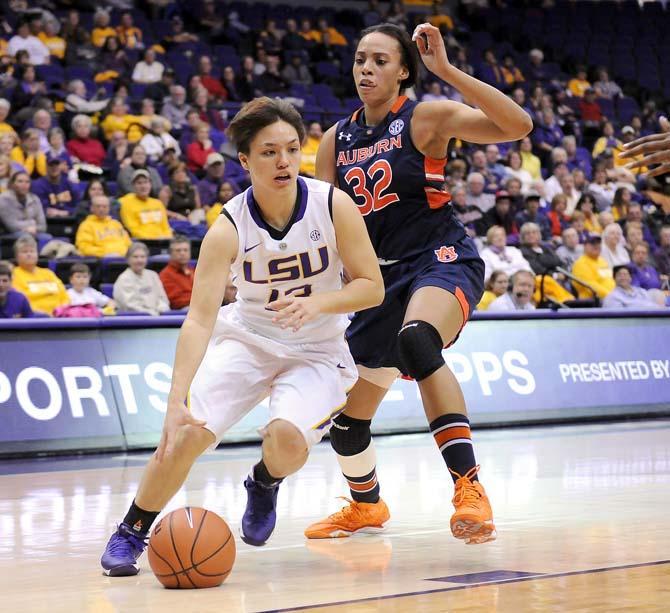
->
xmin=0 ymin=0 xmax=670 ymax=317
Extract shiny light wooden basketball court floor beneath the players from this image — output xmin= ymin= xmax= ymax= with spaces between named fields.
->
xmin=0 ymin=420 xmax=670 ymax=613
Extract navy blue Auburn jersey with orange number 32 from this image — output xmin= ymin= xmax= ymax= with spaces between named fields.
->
xmin=335 ymin=96 xmax=465 ymax=260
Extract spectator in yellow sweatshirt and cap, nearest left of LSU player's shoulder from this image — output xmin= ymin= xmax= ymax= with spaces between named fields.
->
xmin=119 ymin=168 xmax=172 ymax=240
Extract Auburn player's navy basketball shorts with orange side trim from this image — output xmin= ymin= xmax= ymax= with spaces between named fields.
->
xmin=347 ymin=236 xmax=484 ymax=380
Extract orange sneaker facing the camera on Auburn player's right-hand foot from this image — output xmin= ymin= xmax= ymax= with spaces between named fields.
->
xmin=451 ymin=466 xmax=496 ymax=545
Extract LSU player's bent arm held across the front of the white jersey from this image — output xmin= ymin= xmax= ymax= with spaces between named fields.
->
xmin=268 ymin=188 xmax=384 ymax=330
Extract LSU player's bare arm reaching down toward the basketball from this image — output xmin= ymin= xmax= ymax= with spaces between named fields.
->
xmin=156 ymin=215 xmax=238 ymax=461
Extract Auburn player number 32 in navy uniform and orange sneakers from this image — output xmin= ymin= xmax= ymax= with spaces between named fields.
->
xmin=305 ymin=24 xmax=532 ymax=543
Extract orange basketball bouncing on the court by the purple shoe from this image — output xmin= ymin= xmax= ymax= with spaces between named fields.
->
xmin=148 ymin=507 xmax=235 ymax=589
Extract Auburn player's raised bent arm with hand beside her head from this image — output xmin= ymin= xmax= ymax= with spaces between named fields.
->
xmin=412 ymin=23 xmax=533 ymax=148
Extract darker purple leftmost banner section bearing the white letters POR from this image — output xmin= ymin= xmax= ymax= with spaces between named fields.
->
xmin=0 ymin=330 xmax=125 ymax=453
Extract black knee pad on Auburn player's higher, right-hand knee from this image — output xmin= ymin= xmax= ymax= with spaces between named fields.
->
xmin=397 ymin=319 xmax=444 ymax=381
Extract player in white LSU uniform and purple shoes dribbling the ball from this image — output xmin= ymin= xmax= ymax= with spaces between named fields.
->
xmin=101 ymin=98 xmax=384 ymax=576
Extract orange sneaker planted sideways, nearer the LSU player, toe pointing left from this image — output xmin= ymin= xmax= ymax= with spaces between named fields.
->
xmin=305 ymin=496 xmax=391 ymax=539
